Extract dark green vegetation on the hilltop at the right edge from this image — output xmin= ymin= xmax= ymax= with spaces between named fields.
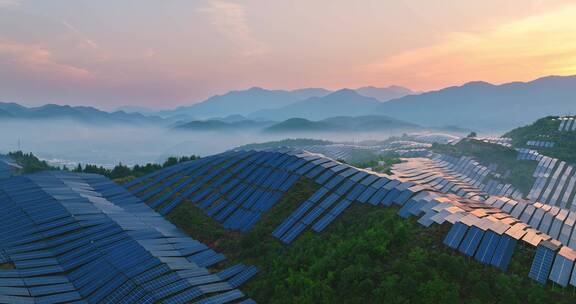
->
xmin=504 ymin=116 xmax=576 ymax=163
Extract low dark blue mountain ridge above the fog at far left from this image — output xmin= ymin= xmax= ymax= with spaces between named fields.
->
xmin=0 ymin=103 xmax=169 ymax=124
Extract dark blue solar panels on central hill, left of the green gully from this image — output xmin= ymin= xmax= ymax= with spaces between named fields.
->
xmin=126 ymin=151 xmax=304 ymax=231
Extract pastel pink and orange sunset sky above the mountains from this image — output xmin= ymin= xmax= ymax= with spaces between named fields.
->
xmin=0 ymin=0 xmax=576 ymax=109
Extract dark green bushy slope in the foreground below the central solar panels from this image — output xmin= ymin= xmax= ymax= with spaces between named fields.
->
xmin=168 ymin=180 xmax=575 ymax=303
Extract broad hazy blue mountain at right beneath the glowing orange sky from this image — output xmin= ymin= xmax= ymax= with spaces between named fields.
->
xmin=377 ymin=76 xmax=576 ymax=131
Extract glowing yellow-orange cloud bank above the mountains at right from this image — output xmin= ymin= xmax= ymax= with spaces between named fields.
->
xmin=360 ymin=5 xmax=576 ymax=89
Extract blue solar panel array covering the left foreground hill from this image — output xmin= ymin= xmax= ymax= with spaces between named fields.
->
xmin=0 ymin=172 xmax=257 ymax=303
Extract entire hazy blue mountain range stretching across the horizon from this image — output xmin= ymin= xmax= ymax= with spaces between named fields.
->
xmin=5 ymin=76 xmax=576 ymax=131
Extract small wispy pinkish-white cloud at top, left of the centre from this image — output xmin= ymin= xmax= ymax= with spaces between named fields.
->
xmin=198 ymin=0 xmax=267 ymax=56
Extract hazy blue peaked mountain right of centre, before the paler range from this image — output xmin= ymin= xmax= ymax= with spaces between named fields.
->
xmin=248 ymin=89 xmax=380 ymax=120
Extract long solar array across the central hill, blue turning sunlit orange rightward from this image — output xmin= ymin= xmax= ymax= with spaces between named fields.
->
xmin=128 ymin=151 xmax=576 ymax=288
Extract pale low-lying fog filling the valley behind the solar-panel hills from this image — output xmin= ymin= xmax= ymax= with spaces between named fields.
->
xmin=0 ymin=121 xmax=446 ymax=167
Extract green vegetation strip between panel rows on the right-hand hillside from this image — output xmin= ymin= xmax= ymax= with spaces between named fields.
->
xmin=431 ymin=138 xmax=538 ymax=194
